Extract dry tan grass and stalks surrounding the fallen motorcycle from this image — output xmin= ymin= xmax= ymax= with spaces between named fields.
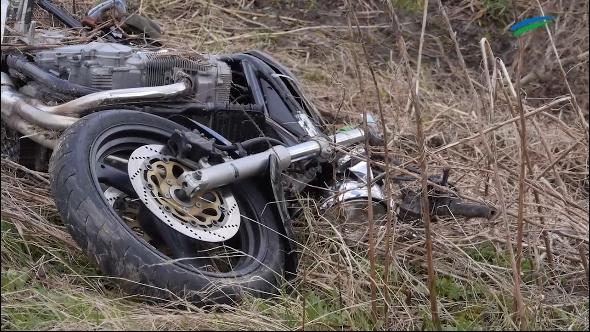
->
xmin=2 ymin=0 xmax=589 ymax=330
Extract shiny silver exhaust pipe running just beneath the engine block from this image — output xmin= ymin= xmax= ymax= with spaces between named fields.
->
xmin=44 ymin=81 xmax=191 ymax=116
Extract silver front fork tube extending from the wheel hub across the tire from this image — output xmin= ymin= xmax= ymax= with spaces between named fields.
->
xmin=185 ymin=129 xmax=364 ymax=196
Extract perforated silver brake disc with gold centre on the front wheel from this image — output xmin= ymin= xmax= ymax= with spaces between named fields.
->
xmin=127 ymin=144 xmax=241 ymax=242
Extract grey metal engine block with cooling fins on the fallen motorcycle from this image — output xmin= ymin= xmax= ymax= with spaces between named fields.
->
xmin=35 ymin=42 xmax=231 ymax=103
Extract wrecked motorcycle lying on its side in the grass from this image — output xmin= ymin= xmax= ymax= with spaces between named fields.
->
xmin=1 ymin=0 xmax=496 ymax=304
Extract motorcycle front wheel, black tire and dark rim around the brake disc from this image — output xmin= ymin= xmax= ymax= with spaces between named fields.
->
xmin=49 ymin=110 xmax=285 ymax=304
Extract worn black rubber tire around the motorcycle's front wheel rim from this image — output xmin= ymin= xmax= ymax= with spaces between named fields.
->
xmin=49 ymin=110 xmax=285 ymax=304
